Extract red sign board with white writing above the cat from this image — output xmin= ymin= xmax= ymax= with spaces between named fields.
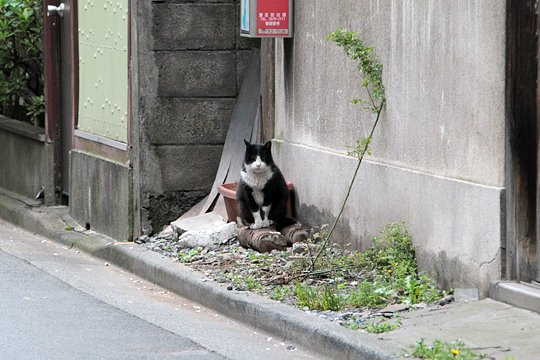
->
xmin=240 ymin=0 xmax=293 ymax=37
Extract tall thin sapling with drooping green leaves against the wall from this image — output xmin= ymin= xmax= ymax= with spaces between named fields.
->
xmin=312 ymin=28 xmax=386 ymax=270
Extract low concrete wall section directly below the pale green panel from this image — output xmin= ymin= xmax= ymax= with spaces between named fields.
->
xmin=69 ymin=150 xmax=133 ymax=241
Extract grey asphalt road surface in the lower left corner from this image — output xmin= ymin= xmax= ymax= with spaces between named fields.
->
xmin=0 ymin=220 xmax=321 ymax=360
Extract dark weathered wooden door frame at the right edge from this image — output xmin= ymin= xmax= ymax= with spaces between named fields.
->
xmin=502 ymin=0 xmax=540 ymax=281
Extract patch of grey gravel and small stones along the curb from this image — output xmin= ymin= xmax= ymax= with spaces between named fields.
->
xmin=135 ymin=234 xmax=438 ymax=329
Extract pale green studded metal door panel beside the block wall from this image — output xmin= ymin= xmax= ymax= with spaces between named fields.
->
xmin=77 ymin=0 xmax=128 ymax=143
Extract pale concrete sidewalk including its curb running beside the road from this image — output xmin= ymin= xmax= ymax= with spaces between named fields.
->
xmin=0 ymin=192 xmax=540 ymax=360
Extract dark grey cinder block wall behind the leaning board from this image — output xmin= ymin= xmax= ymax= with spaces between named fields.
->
xmin=132 ymin=0 xmax=258 ymax=233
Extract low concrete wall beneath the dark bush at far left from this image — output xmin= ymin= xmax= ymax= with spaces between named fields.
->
xmin=0 ymin=115 xmax=46 ymax=199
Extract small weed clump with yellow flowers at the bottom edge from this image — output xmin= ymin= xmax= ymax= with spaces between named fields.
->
xmin=408 ymin=339 xmax=486 ymax=360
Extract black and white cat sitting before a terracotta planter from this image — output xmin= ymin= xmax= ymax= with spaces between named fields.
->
xmin=236 ymin=140 xmax=296 ymax=231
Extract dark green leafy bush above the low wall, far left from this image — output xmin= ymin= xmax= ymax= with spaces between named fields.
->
xmin=0 ymin=0 xmax=44 ymax=126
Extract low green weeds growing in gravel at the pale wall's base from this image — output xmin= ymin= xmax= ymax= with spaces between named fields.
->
xmin=295 ymin=223 xmax=445 ymax=310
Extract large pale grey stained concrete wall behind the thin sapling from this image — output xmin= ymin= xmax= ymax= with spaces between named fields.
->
xmin=275 ymin=0 xmax=505 ymax=292
